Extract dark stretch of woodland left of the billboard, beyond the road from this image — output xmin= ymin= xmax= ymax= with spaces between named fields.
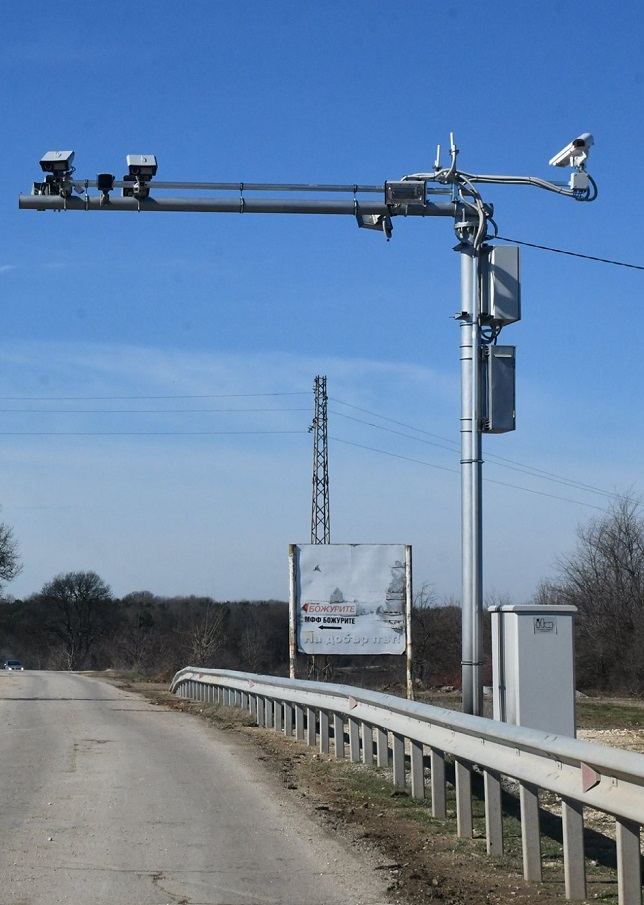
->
xmin=0 ymin=572 xmax=288 ymax=675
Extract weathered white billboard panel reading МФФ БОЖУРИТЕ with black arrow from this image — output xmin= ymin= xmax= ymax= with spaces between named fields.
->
xmin=291 ymin=544 xmax=411 ymax=655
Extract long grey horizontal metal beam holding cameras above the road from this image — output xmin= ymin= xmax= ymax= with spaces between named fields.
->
xmin=18 ymin=195 xmax=458 ymax=217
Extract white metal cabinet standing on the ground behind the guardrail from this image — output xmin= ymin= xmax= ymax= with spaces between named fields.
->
xmin=491 ymin=606 xmax=577 ymax=738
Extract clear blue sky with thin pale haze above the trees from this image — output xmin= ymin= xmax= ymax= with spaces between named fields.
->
xmin=0 ymin=0 xmax=644 ymax=603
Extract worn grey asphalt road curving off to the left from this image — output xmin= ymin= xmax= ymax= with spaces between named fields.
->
xmin=0 ymin=671 xmax=389 ymax=905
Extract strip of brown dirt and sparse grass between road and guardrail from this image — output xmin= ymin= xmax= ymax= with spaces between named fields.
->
xmin=101 ymin=674 xmax=644 ymax=905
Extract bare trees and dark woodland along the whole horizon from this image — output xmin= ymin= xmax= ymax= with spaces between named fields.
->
xmin=0 ymin=497 xmax=644 ymax=694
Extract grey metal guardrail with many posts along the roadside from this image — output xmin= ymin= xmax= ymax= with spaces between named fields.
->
xmin=170 ymin=667 xmax=644 ymax=905
